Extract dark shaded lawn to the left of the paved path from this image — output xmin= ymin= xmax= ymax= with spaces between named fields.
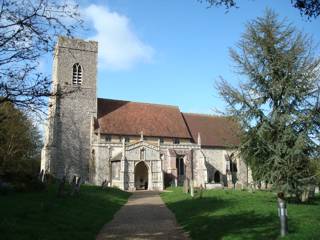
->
xmin=0 ymin=185 xmax=130 ymax=240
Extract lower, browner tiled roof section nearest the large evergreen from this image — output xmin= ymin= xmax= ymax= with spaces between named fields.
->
xmin=183 ymin=113 xmax=240 ymax=147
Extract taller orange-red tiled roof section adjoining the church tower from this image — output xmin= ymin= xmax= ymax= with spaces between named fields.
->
xmin=96 ymin=98 xmax=191 ymax=138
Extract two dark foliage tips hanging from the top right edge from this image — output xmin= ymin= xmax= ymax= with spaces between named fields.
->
xmin=199 ymin=0 xmax=320 ymax=19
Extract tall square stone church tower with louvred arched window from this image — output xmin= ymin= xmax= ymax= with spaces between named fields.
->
xmin=41 ymin=37 xmax=98 ymax=180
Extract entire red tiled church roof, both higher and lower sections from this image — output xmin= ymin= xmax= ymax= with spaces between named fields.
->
xmin=95 ymin=98 xmax=240 ymax=147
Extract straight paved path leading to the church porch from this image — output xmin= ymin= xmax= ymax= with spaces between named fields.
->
xmin=97 ymin=191 xmax=189 ymax=240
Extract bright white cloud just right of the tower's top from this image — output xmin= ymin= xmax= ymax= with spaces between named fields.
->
xmin=85 ymin=4 xmax=154 ymax=69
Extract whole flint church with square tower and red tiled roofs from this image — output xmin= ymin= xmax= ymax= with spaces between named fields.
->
xmin=41 ymin=37 xmax=249 ymax=191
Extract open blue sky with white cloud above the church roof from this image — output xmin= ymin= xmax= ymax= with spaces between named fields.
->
xmin=42 ymin=0 xmax=320 ymax=114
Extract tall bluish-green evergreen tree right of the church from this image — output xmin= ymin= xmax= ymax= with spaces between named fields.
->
xmin=217 ymin=10 xmax=320 ymax=201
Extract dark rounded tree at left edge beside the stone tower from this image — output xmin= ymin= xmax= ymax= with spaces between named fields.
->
xmin=0 ymin=102 xmax=42 ymax=181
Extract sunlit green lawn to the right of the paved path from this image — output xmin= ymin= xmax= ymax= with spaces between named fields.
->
xmin=161 ymin=188 xmax=320 ymax=240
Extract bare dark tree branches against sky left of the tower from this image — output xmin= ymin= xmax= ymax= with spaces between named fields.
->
xmin=0 ymin=0 xmax=83 ymax=116
